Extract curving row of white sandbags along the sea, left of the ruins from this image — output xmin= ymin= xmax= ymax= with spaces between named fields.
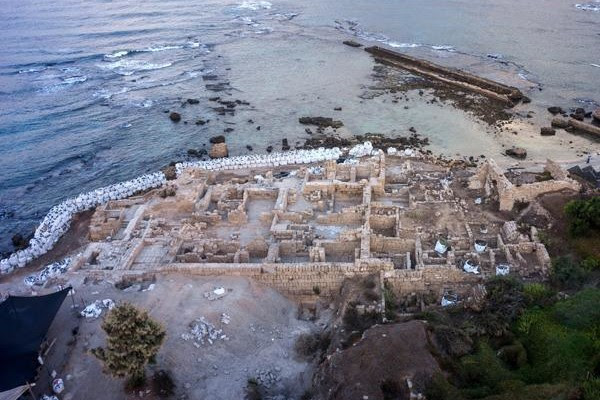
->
xmin=0 ymin=172 xmax=166 ymax=274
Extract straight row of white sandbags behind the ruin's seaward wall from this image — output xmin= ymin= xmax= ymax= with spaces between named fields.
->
xmin=175 ymin=147 xmax=342 ymax=176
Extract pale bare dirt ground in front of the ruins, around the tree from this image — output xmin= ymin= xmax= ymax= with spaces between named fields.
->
xmin=27 ymin=275 xmax=322 ymax=400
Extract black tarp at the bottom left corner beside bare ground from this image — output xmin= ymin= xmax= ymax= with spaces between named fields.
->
xmin=0 ymin=288 xmax=70 ymax=392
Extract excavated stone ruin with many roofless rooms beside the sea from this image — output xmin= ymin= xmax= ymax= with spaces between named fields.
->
xmin=25 ymin=144 xmax=578 ymax=304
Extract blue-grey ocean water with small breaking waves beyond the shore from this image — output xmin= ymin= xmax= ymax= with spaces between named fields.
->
xmin=0 ymin=0 xmax=600 ymax=251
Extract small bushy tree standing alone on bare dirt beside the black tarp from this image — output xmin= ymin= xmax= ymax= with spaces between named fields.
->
xmin=92 ymin=303 xmax=165 ymax=386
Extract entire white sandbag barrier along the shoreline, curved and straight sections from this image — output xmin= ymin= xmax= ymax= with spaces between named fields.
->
xmin=0 ymin=147 xmax=352 ymax=274
